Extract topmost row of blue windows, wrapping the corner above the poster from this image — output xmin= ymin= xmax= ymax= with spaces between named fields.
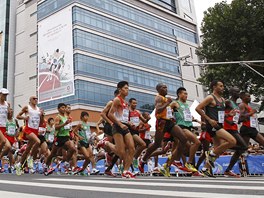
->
xmin=38 ymin=0 xmax=197 ymax=43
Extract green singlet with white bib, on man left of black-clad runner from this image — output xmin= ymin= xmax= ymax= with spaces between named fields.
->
xmin=174 ymin=100 xmax=193 ymax=127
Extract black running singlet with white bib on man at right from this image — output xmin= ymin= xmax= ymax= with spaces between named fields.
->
xmin=205 ymin=94 xmax=225 ymax=124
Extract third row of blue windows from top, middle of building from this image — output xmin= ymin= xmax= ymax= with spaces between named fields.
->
xmin=73 ymin=29 xmax=180 ymax=75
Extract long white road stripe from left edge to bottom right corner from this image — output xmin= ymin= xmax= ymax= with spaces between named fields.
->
xmin=0 ymin=180 xmax=263 ymax=198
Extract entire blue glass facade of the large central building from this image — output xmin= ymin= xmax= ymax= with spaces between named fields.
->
xmin=38 ymin=0 xmax=196 ymax=112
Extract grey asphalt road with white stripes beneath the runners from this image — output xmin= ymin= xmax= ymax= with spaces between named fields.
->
xmin=0 ymin=174 xmax=264 ymax=198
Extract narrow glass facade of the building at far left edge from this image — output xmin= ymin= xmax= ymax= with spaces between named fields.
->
xmin=0 ymin=0 xmax=10 ymax=88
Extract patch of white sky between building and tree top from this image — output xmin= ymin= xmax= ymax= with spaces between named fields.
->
xmin=194 ymin=0 xmax=232 ymax=32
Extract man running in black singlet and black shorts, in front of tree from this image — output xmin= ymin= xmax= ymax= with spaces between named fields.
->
xmin=196 ymin=80 xmax=236 ymax=177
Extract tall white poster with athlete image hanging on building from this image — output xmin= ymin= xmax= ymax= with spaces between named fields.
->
xmin=38 ymin=7 xmax=74 ymax=103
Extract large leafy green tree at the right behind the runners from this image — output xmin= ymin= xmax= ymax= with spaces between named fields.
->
xmin=197 ymin=0 xmax=264 ymax=105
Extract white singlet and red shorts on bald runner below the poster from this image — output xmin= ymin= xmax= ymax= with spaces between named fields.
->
xmin=24 ymin=105 xmax=40 ymax=136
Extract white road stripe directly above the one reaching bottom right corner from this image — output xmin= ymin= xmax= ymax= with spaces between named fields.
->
xmin=36 ymin=178 xmax=264 ymax=190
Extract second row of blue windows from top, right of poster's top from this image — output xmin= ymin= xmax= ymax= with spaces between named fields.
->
xmin=73 ymin=7 xmax=178 ymax=55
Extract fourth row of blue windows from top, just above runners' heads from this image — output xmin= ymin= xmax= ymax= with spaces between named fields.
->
xmin=74 ymin=54 xmax=182 ymax=94
